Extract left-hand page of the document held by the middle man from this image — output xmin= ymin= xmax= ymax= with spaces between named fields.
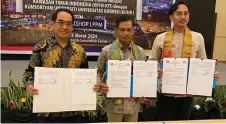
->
xmin=107 ymin=60 xmax=131 ymax=97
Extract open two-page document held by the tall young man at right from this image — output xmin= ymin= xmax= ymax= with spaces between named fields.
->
xmin=162 ymin=58 xmax=216 ymax=96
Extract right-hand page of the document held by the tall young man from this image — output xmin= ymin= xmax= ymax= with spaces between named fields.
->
xmin=187 ymin=58 xmax=216 ymax=96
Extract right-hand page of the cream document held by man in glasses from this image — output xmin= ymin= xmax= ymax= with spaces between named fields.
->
xmin=70 ymin=69 xmax=97 ymax=110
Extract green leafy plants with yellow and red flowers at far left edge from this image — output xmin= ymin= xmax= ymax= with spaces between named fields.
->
xmin=1 ymin=71 xmax=32 ymax=112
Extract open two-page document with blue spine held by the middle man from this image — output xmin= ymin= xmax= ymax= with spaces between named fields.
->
xmin=107 ymin=60 xmax=158 ymax=97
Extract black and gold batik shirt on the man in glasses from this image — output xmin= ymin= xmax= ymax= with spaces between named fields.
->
xmin=23 ymin=37 xmax=88 ymax=116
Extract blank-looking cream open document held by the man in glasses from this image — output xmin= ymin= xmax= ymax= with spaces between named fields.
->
xmin=33 ymin=67 xmax=97 ymax=113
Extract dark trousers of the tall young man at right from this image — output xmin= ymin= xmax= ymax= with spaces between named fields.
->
xmin=156 ymin=94 xmax=193 ymax=121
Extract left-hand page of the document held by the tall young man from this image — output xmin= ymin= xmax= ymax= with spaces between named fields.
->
xmin=162 ymin=58 xmax=188 ymax=94
